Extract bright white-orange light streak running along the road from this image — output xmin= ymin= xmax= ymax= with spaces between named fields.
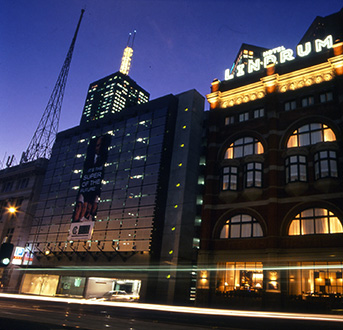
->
xmin=0 ymin=293 xmax=343 ymax=323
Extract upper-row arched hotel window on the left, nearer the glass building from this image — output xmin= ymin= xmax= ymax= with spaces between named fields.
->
xmin=225 ymin=136 xmax=264 ymax=159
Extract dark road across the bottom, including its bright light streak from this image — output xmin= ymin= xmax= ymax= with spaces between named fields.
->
xmin=0 ymin=294 xmax=343 ymax=330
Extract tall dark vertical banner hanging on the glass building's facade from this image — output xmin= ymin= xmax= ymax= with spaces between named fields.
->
xmin=68 ymin=134 xmax=111 ymax=239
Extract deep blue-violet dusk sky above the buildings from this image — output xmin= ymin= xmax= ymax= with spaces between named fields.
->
xmin=0 ymin=0 xmax=343 ymax=168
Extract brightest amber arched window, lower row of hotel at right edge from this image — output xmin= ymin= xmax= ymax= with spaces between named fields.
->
xmin=288 ymin=208 xmax=343 ymax=236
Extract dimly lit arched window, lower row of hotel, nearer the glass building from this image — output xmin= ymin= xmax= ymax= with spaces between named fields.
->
xmin=220 ymin=214 xmax=263 ymax=238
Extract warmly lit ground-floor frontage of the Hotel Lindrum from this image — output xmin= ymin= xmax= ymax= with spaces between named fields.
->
xmin=203 ymin=261 xmax=343 ymax=312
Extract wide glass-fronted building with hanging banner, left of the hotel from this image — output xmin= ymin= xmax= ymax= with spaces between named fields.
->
xmin=21 ymin=87 xmax=204 ymax=302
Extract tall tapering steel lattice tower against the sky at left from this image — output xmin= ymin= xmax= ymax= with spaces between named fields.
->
xmin=20 ymin=9 xmax=85 ymax=163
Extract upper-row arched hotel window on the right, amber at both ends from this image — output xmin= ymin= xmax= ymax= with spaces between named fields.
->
xmin=287 ymin=123 xmax=336 ymax=148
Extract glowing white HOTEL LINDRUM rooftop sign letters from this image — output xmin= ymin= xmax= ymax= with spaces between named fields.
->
xmin=225 ymin=35 xmax=333 ymax=80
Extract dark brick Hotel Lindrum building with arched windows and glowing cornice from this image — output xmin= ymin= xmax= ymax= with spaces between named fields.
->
xmin=197 ymin=10 xmax=343 ymax=311
